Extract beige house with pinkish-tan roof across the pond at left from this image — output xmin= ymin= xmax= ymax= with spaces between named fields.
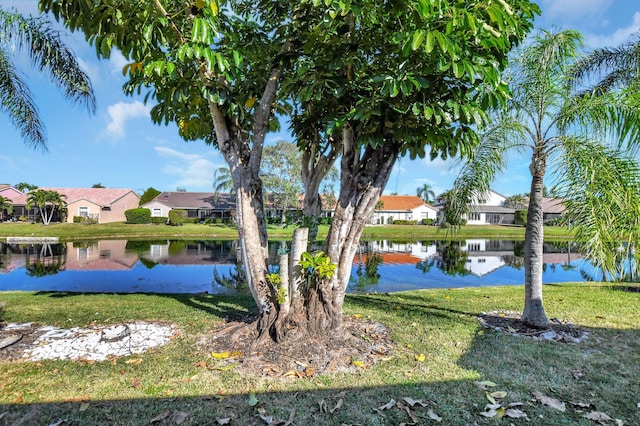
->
xmin=39 ymin=188 xmax=140 ymax=223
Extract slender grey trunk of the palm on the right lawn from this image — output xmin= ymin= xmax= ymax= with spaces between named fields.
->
xmin=522 ymin=146 xmax=548 ymax=327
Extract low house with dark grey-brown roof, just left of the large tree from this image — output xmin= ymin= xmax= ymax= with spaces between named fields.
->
xmin=140 ymin=191 xmax=236 ymax=221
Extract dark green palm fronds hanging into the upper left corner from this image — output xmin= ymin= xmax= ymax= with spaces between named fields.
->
xmin=0 ymin=7 xmax=96 ymax=149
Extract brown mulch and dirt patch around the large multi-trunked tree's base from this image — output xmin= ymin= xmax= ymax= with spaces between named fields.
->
xmin=199 ymin=316 xmax=395 ymax=378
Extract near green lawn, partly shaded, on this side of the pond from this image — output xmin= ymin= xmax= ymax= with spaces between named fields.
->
xmin=0 ymin=283 xmax=640 ymax=425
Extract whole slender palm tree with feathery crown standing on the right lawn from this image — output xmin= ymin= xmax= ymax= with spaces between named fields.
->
xmin=453 ymin=31 xmax=640 ymax=327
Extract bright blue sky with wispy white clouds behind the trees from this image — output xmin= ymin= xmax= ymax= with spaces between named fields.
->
xmin=0 ymin=0 xmax=640 ymax=195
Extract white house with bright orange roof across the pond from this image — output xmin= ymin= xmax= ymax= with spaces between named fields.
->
xmin=369 ymin=195 xmax=438 ymax=225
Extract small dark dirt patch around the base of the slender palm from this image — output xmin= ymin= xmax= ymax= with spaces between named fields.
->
xmin=478 ymin=311 xmax=589 ymax=343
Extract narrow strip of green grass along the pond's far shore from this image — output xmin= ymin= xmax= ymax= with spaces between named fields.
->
xmin=0 ymin=223 xmax=572 ymax=241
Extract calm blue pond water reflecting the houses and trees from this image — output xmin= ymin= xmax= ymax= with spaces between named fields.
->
xmin=0 ymin=239 xmax=597 ymax=293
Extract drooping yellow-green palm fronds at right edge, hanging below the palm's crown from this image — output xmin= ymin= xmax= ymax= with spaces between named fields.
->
xmin=555 ymin=137 xmax=640 ymax=279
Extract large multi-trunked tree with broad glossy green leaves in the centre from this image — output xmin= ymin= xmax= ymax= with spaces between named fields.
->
xmin=40 ymin=0 xmax=539 ymax=340
